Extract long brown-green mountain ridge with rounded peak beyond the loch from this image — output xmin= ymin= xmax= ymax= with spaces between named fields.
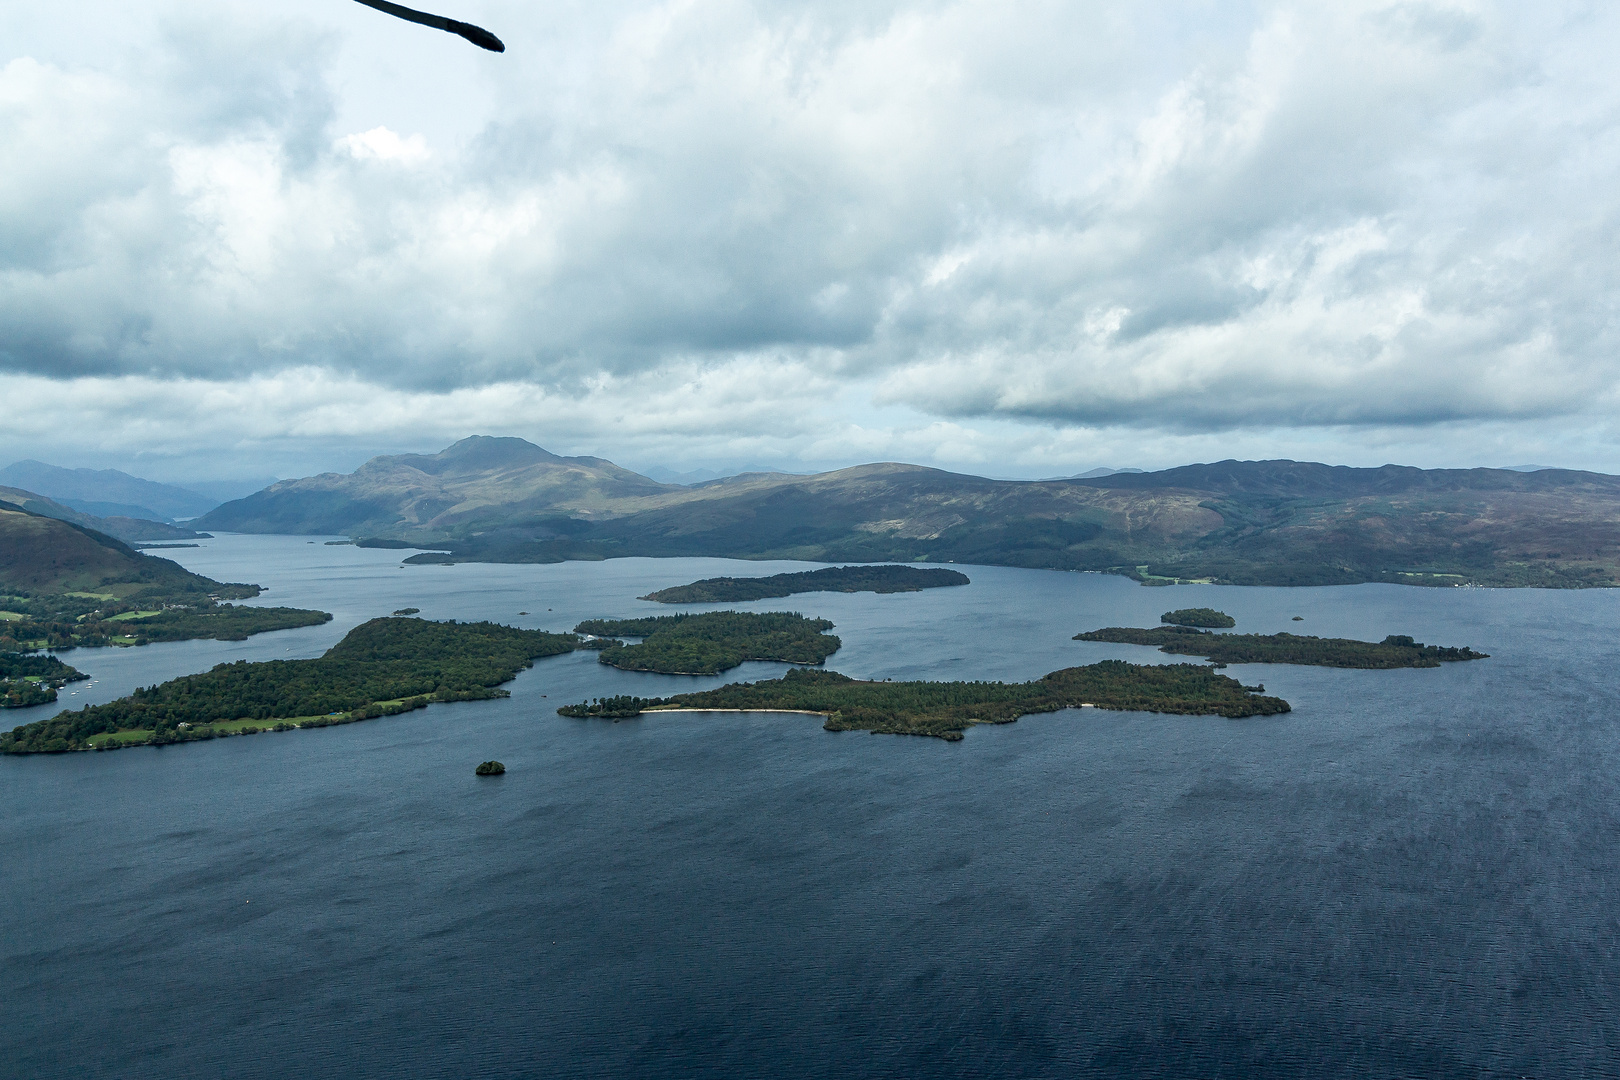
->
xmin=196 ymin=436 xmax=1620 ymax=586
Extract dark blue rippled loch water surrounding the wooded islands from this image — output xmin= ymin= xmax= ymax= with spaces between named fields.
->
xmin=0 ymin=538 xmax=1620 ymax=1078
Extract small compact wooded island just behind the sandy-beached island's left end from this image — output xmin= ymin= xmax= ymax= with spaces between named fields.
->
xmin=573 ymin=612 xmax=842 ymax=675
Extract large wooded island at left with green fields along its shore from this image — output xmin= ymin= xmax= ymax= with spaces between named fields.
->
xmin=0 ymin=619 xmax=578 ymax=753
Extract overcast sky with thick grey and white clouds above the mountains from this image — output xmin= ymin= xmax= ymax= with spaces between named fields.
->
xmin=0 ymin=0 xmax=1620 ymax=481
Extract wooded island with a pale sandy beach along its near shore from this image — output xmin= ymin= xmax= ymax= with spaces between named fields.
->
xmin=557 ymin=661 xmax=1290 ymax=740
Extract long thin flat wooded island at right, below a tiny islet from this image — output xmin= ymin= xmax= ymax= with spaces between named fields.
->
xmin=1074 ymin=627 xmax=1489 ymax=669
